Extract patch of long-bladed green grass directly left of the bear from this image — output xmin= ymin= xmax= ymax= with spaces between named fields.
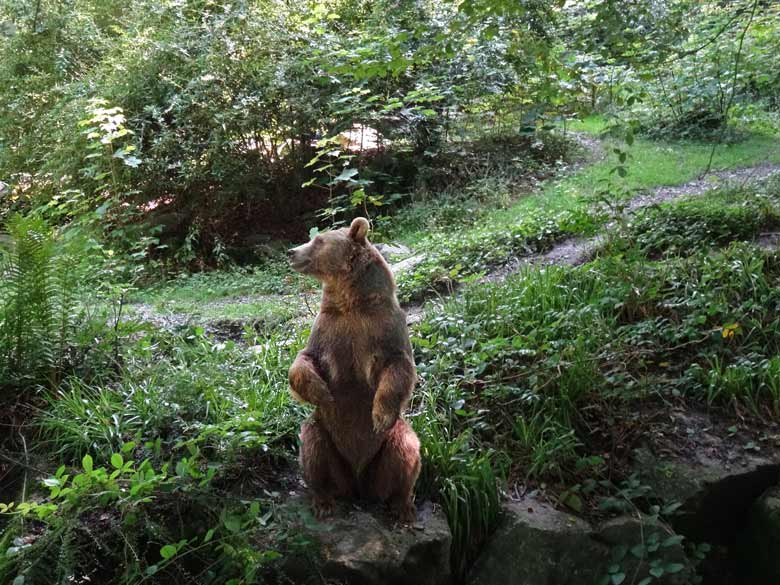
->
xmin=40 ymin=332 xmax=301 ymax=458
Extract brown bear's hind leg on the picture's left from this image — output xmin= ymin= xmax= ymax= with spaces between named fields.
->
xmin=301 ymin=420 xmax=355 ymax=519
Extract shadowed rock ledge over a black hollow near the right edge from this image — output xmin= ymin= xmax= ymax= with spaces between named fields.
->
xmin=634 ymin=449 xmax=780 ymax=545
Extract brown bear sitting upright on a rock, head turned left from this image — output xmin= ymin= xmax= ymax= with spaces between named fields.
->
xmin=288 ymin=217 xmax=420 ymax=522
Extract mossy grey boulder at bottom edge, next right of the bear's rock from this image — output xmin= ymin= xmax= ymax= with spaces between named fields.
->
xmin=468 ymin=498 xmax=608 ymax=585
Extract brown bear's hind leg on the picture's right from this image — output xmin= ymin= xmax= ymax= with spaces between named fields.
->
xmin=366 ymin=419 xmax=420 ymax=522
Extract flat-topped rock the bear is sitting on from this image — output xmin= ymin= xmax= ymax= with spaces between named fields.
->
xmin=288 ymin=503 xmax=452 ymax=585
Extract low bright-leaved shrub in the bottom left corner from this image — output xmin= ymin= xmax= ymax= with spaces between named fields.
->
xmin=0 ymin=443 xmax=279 ymax=585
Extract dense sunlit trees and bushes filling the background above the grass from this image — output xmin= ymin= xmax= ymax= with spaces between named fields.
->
xmin=0 ymin=0 xmax=780 ymax=262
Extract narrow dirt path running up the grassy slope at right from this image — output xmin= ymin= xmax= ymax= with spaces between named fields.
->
xmin=406 ymin=163 xmax=780 ymax=324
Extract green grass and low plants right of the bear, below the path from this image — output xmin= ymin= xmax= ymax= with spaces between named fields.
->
xmin=415 ymin=237 xmax=780 ymax=485
